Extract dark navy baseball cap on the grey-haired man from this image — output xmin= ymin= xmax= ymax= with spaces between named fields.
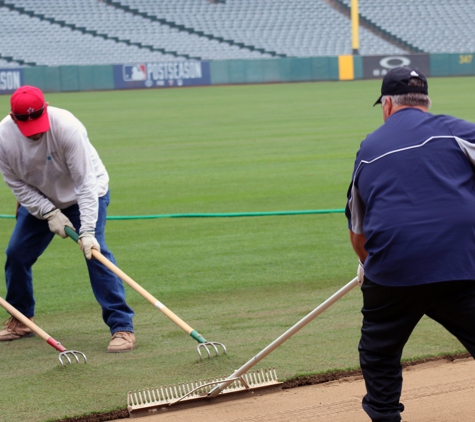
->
xmin=373 ymin=66 xmax=429 ymax=107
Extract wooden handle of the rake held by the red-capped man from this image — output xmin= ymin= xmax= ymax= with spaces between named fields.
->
xmin=64 ymin=226 xmax=207 ymax=343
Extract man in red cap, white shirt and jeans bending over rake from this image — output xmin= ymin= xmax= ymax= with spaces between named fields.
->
xmin=0 ymin=86 xmax=135 ymax=353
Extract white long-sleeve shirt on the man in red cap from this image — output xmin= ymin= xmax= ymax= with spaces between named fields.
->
xmin=0 ymin=106 xmax=109 ymax=231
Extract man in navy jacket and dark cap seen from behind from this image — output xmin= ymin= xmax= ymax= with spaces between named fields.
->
xmin=346 ymin=67 xmax=475 ymax=422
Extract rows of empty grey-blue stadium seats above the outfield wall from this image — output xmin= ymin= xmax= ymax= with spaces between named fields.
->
xmin=0 ymin=0 xmax=475 ymax=66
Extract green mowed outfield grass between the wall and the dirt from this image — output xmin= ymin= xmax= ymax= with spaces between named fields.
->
xmin=0 ymin=77 xmax=475 ymax=422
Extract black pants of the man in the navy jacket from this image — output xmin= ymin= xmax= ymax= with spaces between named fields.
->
xmin=358 ymin=278 xmax=475 ymax=422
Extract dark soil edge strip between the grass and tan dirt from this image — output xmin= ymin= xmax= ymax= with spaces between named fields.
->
xmin=51 ymin=352 xmax=471 ymax=422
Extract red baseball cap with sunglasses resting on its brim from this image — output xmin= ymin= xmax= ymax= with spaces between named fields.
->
xmin=10 ymin=85 xmax=50 ymax=136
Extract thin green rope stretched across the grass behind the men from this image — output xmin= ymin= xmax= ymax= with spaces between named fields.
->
xmin=0 ymin=209 xmax=345 ymax=220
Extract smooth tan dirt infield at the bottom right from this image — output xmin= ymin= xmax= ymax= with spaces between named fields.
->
xmin=109 ymin=357 xmax=475 ymax=422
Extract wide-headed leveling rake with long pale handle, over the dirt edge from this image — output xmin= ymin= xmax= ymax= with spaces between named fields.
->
xmin=127 ymin=277 xmax=358 ymax=417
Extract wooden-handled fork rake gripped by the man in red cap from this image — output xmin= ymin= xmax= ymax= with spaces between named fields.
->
xmin=65 ymin=227 xmax=227 ymax=359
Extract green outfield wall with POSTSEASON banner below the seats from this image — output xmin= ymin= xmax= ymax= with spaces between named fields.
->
xmin=0 ymin=53 xmax=475 ymax=94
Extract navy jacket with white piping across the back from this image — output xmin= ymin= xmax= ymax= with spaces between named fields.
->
xmin=346 ymin=108 xmax=475 ymax=286
